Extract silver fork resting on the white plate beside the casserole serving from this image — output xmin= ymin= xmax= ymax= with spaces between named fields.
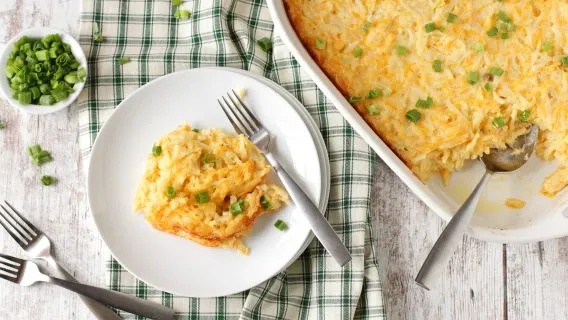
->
xmin=217 ymin=90 xmax=351 ymax=266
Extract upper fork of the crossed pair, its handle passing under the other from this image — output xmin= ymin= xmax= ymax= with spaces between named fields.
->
xmin=0 ymin=201 xmax=120 ymax=320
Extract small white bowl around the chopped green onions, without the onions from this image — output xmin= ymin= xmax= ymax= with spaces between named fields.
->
xmin=0 ymin=27 xmax=89 ymax=114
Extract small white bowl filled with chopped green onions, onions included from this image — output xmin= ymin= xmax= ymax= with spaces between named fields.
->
xmin=0 ymin=27 xmax=87 ymax=114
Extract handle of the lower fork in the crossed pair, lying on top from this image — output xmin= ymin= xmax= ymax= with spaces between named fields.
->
xmin=47 ymin=277 xmax=174 ymax=320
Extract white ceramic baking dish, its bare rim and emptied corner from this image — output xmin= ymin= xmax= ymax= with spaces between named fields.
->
xmin=268 ymin=0 xmax=568 ymax=242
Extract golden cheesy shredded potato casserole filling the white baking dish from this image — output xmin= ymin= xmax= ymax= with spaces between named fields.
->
xmin=285 ymin=0 xmax=568 ymax=196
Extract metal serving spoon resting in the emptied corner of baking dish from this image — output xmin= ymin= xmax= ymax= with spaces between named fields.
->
xmin=415 ymin=125 xmax=538 ymax=290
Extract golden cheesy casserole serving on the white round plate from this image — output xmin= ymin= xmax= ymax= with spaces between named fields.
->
xmin=134 ymin=125 xmax=289 ymax=254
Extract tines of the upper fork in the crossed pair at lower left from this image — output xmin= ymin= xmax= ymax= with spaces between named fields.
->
xmin=0 ymin=201 xmax=41 ymax=248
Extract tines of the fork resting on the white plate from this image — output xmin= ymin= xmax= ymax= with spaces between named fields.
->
xmin=217 ymin=90 xmax=262 ymax=136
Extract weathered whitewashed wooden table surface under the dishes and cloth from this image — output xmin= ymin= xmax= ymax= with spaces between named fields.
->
xmin=0 ymin=0 xmax=568 ymax=320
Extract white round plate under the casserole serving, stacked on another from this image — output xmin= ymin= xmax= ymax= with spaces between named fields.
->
xmin=87 ymin=68 xmax=329 ymax=297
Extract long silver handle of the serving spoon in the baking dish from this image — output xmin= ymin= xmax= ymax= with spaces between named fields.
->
xmin=415 ymin=170 xmax=493 ymax=290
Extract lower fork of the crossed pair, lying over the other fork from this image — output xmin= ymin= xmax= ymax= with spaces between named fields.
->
xmin=0 ymin=253 xmax=174 ymax=320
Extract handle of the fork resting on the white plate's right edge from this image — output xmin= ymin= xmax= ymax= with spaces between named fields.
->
xmin=266 ymin=153 xmax=351 ymax=266
